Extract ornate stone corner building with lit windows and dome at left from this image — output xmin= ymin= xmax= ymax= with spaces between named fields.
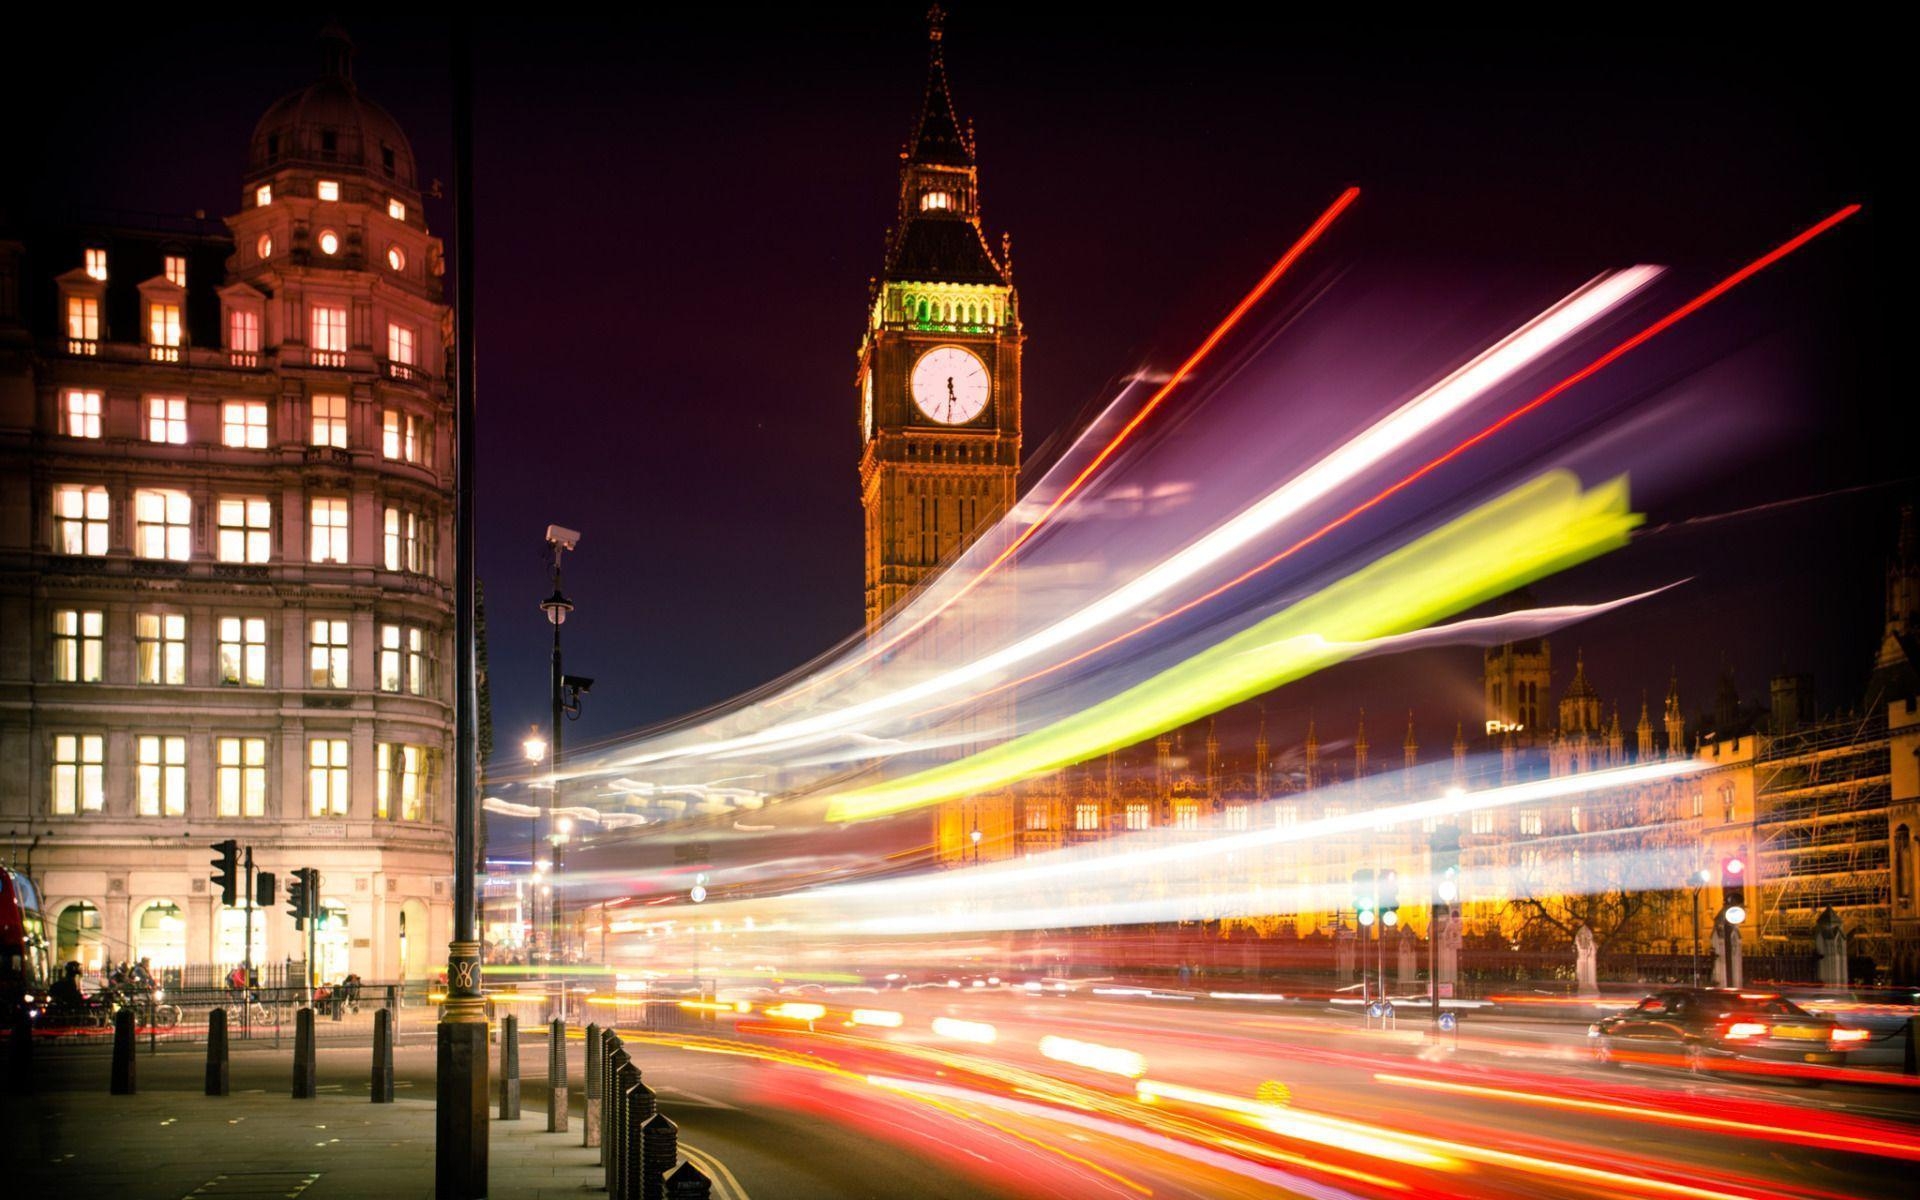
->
xmin=0 ymin=35 xmax=453 ymax=979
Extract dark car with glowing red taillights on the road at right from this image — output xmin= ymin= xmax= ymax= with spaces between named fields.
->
xmin=1586 ymin=987 xmax=1870 ymax=1073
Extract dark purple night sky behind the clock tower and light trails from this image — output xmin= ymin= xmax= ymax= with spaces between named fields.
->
xmin=11 ymin=14 xmax=1914 ymax=775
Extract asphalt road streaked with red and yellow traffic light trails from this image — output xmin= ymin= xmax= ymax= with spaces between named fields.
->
xmin=18 ymin=989 xmax=1920 ymax=1200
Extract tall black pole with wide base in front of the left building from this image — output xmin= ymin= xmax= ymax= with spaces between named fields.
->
xmin=434 ymin=17 xmax=488 ymax=1200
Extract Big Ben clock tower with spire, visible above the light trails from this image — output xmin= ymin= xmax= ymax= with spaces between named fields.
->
xmin=854 ymin=6 xmax=1023 ymax=630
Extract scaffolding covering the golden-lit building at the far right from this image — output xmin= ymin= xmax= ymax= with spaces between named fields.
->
xmin=1753 ymin=712 xmax=1893 ymax=958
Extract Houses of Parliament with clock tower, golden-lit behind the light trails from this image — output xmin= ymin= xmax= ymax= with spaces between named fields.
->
xmin=854 ymin=10 xmax=1920 ymax=983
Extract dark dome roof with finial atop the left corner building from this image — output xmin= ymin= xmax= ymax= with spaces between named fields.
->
xmin=248 ymin=27 xmax=419 ymax=192
